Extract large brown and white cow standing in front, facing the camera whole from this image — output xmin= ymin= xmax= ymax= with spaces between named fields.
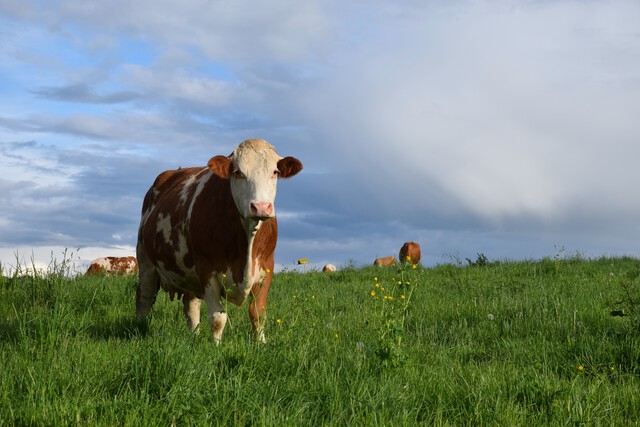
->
xmin=136 ymin=139 xmax=302 ymax=342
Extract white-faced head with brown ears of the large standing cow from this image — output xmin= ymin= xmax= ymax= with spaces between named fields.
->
xmin=209 ymin=139 xmax=302 ymax=219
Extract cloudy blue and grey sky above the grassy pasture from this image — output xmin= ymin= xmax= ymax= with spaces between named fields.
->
xmin=0 ymin=0 xmax=640 ymax=272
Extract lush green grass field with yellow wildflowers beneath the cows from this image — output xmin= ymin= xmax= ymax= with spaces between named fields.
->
xmin=0 ymin=256 xmax=640 ymax=426
